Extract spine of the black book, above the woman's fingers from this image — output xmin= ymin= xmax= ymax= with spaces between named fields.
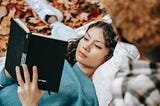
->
xmin=20 ymin=33 xmax=31 ymax=65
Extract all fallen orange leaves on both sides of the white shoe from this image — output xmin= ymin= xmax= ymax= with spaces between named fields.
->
xmin=0 ymin=0 xmax=106 ymax=57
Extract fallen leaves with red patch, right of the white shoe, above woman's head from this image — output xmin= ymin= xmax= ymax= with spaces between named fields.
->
xmin=51 ymin=0 xmax=106 ymax=28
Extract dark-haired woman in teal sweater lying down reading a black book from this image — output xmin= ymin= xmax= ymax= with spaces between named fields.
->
xmin=0 ymin=16 xmax=117 ymax=106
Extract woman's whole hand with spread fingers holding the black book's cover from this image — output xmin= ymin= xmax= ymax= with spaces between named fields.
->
xmin=16 ymin=64 xmax=44 ymax=106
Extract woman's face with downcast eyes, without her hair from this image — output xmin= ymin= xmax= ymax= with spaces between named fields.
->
xmin=76 ymin=27 xmax=109 ymax=68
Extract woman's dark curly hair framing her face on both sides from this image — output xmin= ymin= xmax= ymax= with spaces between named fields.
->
xmin=67 ymin=21 xmax=118 ymax=65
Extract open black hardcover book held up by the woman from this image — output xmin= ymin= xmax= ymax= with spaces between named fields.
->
xmin=5 ymin=18 xmax=68 ymax=92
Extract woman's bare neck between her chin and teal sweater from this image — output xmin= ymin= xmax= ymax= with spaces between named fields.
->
xmin=77 ymin=62 xmax=96 ymax=79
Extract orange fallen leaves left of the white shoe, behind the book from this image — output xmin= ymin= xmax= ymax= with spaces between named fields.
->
xmin=0 ymin=0 xmax=48 ymax=57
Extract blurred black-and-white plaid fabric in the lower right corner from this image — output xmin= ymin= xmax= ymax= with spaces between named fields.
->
xmin=112 ymin=60 xmax=160 ymax=106
